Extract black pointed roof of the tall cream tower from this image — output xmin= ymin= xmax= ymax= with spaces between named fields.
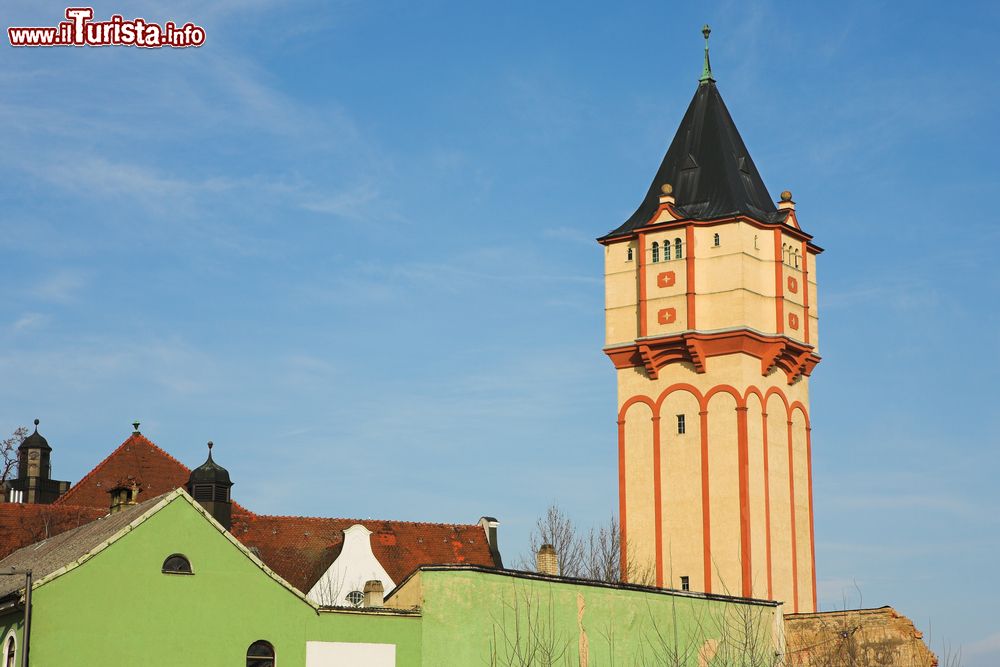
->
xmin=602 ymin=78 xmax=787 ymax=238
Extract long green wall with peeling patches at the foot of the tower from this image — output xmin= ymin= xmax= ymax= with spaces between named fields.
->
xmin=418 ymin=570 xmax=781 ymax=667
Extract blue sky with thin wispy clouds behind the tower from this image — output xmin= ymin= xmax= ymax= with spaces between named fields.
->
xmin=0 ymin=0 xmax=1000 ymax=666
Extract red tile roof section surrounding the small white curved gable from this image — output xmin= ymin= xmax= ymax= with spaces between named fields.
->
xmin=231 ymin=513 xmax=495 ymax=593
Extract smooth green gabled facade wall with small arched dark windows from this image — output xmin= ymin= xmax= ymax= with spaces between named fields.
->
xmin=22 ymin=496 xmax=421 ymax=667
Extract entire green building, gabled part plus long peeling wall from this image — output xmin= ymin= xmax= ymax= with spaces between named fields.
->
xmin=0 ymin=489 xmax=782 ymax=667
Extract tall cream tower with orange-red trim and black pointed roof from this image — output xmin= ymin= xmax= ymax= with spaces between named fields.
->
xmin=598 ymin=26 xmax=822 ymax=612
